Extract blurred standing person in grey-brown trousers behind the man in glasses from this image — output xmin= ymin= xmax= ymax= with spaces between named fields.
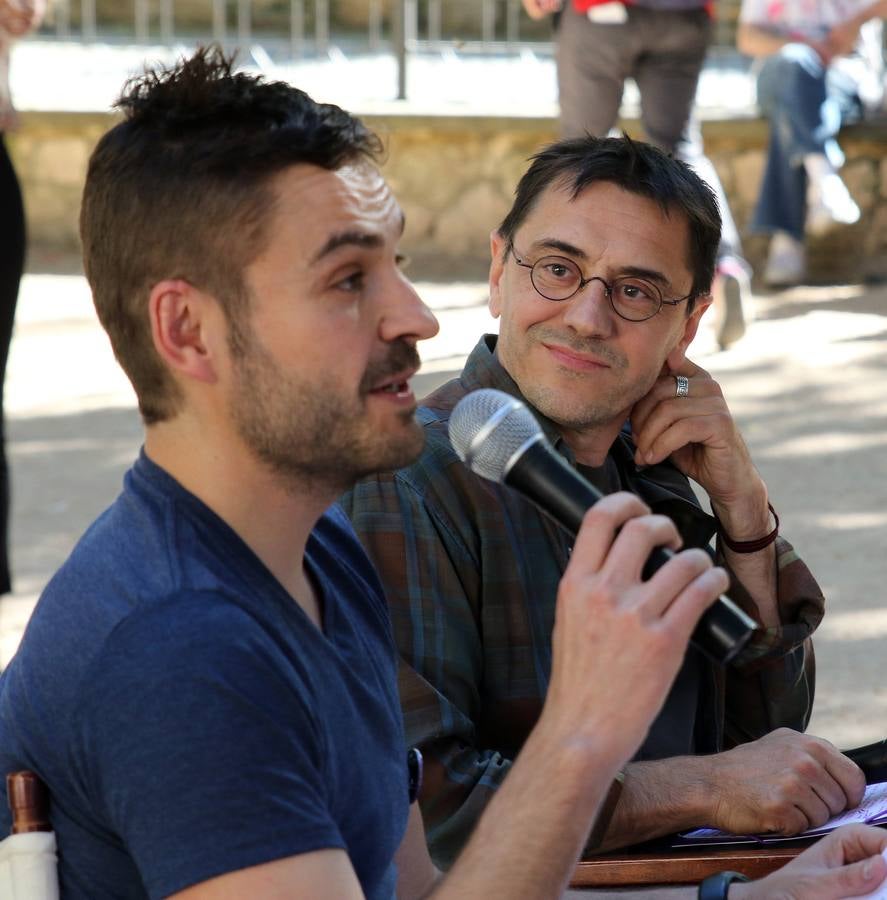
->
xmin=523 ymin=0 xmax=751 ymax=349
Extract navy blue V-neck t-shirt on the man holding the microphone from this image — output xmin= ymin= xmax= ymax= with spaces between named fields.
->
xmin=0 ymin=454 xmax=408 ymax=900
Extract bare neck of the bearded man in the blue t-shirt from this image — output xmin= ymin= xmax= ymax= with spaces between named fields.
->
xmin=145 ymin=420 xmax=336 ymax=626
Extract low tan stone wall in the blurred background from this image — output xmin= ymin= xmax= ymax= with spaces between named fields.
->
xmin=7 ymin=112 xmax=887 ymax=281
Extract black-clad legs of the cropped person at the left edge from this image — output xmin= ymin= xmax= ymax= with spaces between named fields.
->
xmin=0 ymin=133 xmax=25 ymax=594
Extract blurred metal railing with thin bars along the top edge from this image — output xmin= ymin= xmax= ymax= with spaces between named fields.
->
xmin=34 ymin=0 xmax=739 ymax=99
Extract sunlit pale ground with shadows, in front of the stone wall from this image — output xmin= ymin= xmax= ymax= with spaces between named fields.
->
xmin=0 ymin=265 xmax=887 ymax=747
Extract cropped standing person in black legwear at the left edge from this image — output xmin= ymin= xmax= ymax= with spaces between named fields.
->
xmin=0 ymin=0 xmax=46 ymax=594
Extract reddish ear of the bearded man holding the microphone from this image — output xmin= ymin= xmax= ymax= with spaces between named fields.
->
xmin=148 ymin=279 xmax=221 ymax=383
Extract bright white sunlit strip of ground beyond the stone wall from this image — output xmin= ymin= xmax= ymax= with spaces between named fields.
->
xmin=10 ymin=35 xmax=755 ymax=118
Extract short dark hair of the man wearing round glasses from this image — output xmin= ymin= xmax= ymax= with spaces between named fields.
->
xmin=499 ymin=135 xmax=721 ymax=312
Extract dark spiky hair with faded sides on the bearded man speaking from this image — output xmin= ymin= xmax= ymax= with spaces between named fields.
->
xmin=80 ymin=47 xmax=382 ymax=424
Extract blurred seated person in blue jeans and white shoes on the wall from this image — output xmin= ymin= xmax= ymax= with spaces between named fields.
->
xmin=737 ymin=0 xmax=887 ymax=286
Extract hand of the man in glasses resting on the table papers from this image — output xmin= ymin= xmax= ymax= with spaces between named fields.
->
xmin=704 ymin=728 xmax=865 ymax=835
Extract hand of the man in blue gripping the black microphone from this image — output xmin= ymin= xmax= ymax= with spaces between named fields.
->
xmin=543 ymin=493 xmax=727 ymax=766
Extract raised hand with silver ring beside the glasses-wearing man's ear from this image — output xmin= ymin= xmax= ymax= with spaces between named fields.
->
xmin=631 ymin=357 xmax=770 ymax=541
